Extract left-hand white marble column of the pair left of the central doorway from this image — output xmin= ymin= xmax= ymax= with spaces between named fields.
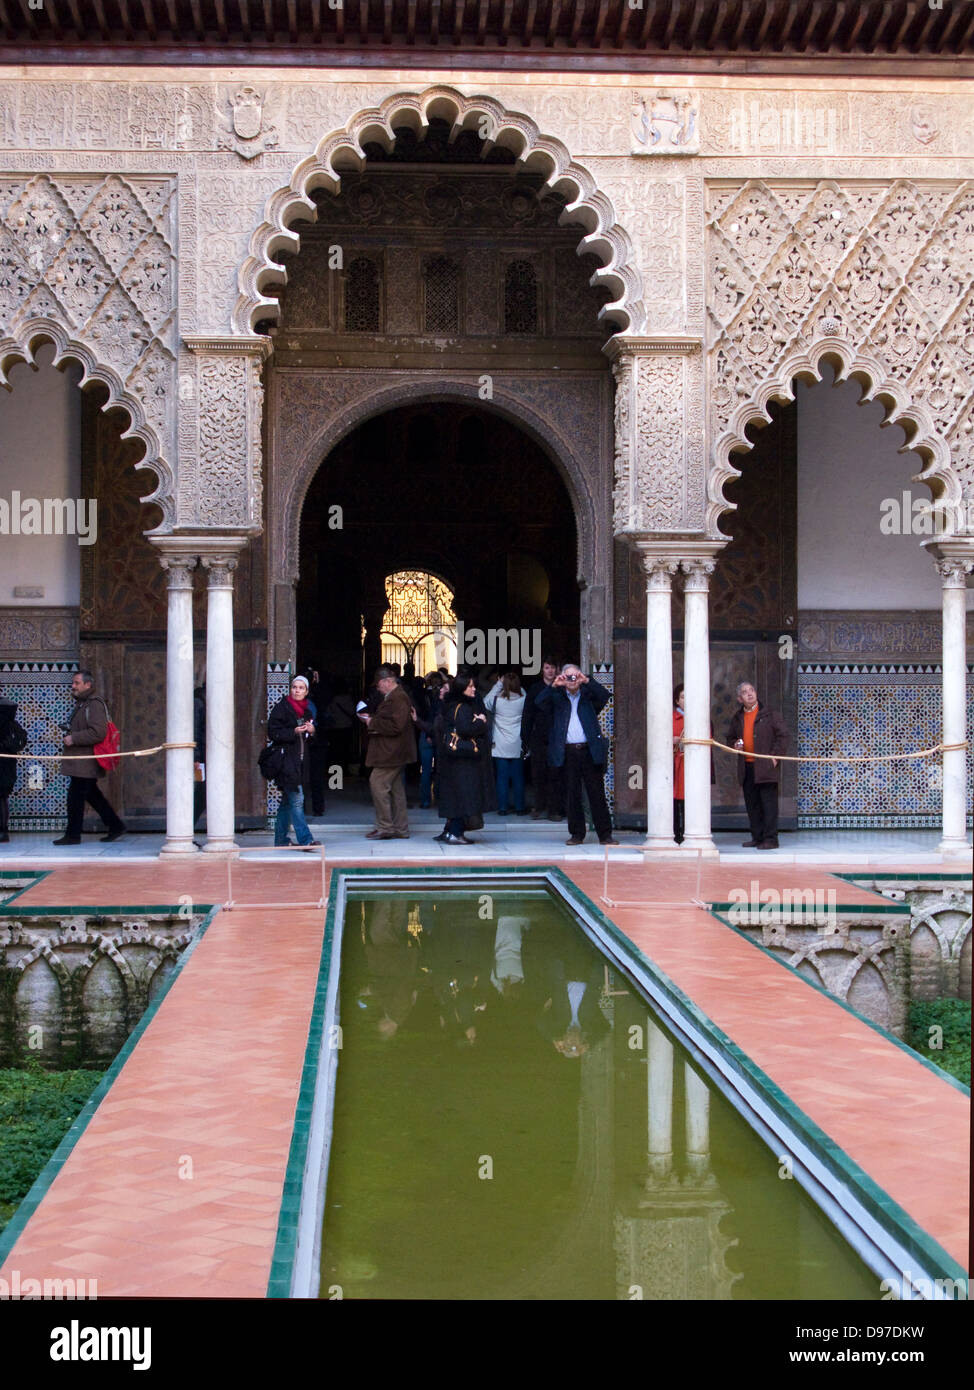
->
xmin=150 ymin=538 xmax=196 ymax=858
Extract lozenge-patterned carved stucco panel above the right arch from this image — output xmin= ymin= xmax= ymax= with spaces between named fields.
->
xmin=707 ymin=179 xmax=974 ymax=524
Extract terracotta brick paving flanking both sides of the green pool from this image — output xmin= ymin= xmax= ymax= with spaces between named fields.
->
xmin=0 ymin=859 xmax=968 ymax=1297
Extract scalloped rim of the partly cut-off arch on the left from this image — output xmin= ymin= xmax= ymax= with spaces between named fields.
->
xmin=0 ymin=318 xmax=175 ymax=535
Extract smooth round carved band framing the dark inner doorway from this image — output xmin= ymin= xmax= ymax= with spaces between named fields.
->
xmin=272 ymin=377 xmax=604 ymax=594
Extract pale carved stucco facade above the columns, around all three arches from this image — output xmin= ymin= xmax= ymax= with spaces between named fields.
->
xmin=0 ymin=67 xmax=974 ymax=834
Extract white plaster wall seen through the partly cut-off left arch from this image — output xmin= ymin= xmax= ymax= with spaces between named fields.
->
xmin=0 ymin=346 xmax=81 ymax=607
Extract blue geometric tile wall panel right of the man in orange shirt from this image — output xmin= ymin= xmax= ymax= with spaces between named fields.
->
xmin=798 ymin=666 xmax=974 ymax=827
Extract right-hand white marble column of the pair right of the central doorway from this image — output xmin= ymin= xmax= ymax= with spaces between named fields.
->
xmin=681 ymin=556 xmax=720 ymax=859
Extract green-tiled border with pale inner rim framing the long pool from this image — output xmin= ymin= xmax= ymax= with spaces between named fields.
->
xmin=267 ymin=865 xmax=967 ymax=1298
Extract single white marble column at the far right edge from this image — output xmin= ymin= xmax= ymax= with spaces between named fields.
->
xmin=936 ymin=541 xmax=974 ymax=863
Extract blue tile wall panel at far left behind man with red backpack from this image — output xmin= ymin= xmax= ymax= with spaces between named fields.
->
xmin=0 ymin=662 xmax=78 ymax=830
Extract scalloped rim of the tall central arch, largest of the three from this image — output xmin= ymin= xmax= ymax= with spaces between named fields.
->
xmin=232 ymin=86 xmax=646 ymax=335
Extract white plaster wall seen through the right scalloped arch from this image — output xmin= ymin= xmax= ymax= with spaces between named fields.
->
xmin=798 ymin=367 xmax=974 ymax=612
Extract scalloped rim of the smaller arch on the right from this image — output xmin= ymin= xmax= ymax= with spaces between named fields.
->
xmin=706 ymin=336 xmax=963 ymax=537
